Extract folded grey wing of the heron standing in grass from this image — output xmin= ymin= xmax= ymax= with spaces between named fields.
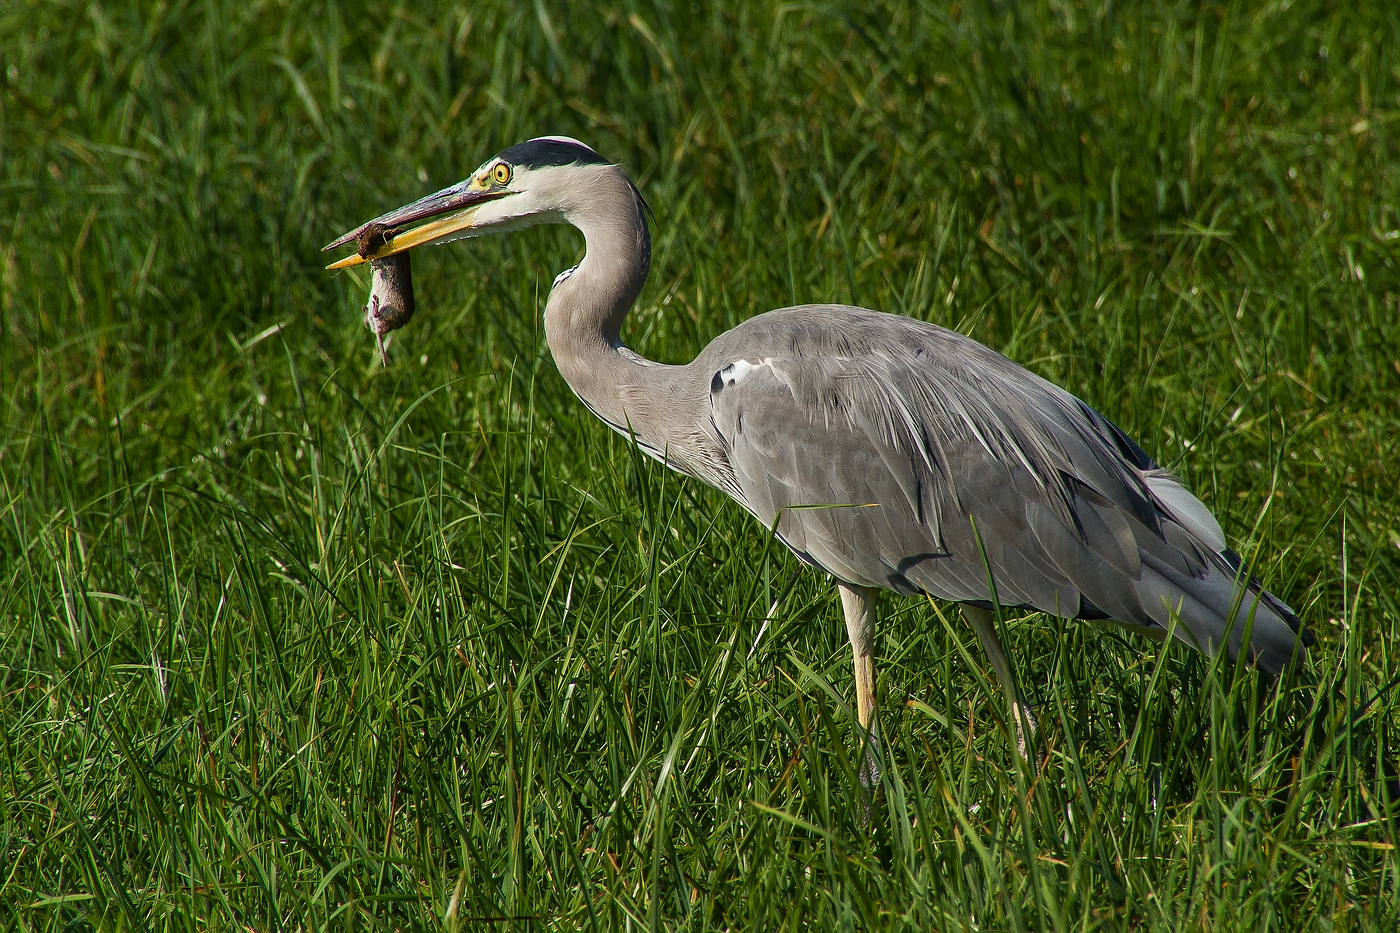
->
xmin=697 ymin=305 xmax=1298 ymax=667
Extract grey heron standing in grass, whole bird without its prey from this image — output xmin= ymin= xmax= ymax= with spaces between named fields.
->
xmin=326 ymin=136 xmax=1310 ymax=785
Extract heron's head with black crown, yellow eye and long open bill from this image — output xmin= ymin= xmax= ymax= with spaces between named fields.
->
xmin=325 ymin=136 xmax=622 ymax=269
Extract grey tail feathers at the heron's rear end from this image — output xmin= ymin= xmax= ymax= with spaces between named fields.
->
xmin=1137 ymin=549 xmax=1312 ymax=674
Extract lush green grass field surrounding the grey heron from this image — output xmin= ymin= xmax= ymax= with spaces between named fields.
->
xmin=0 ymin=0 xmax=1400 ymax=930
